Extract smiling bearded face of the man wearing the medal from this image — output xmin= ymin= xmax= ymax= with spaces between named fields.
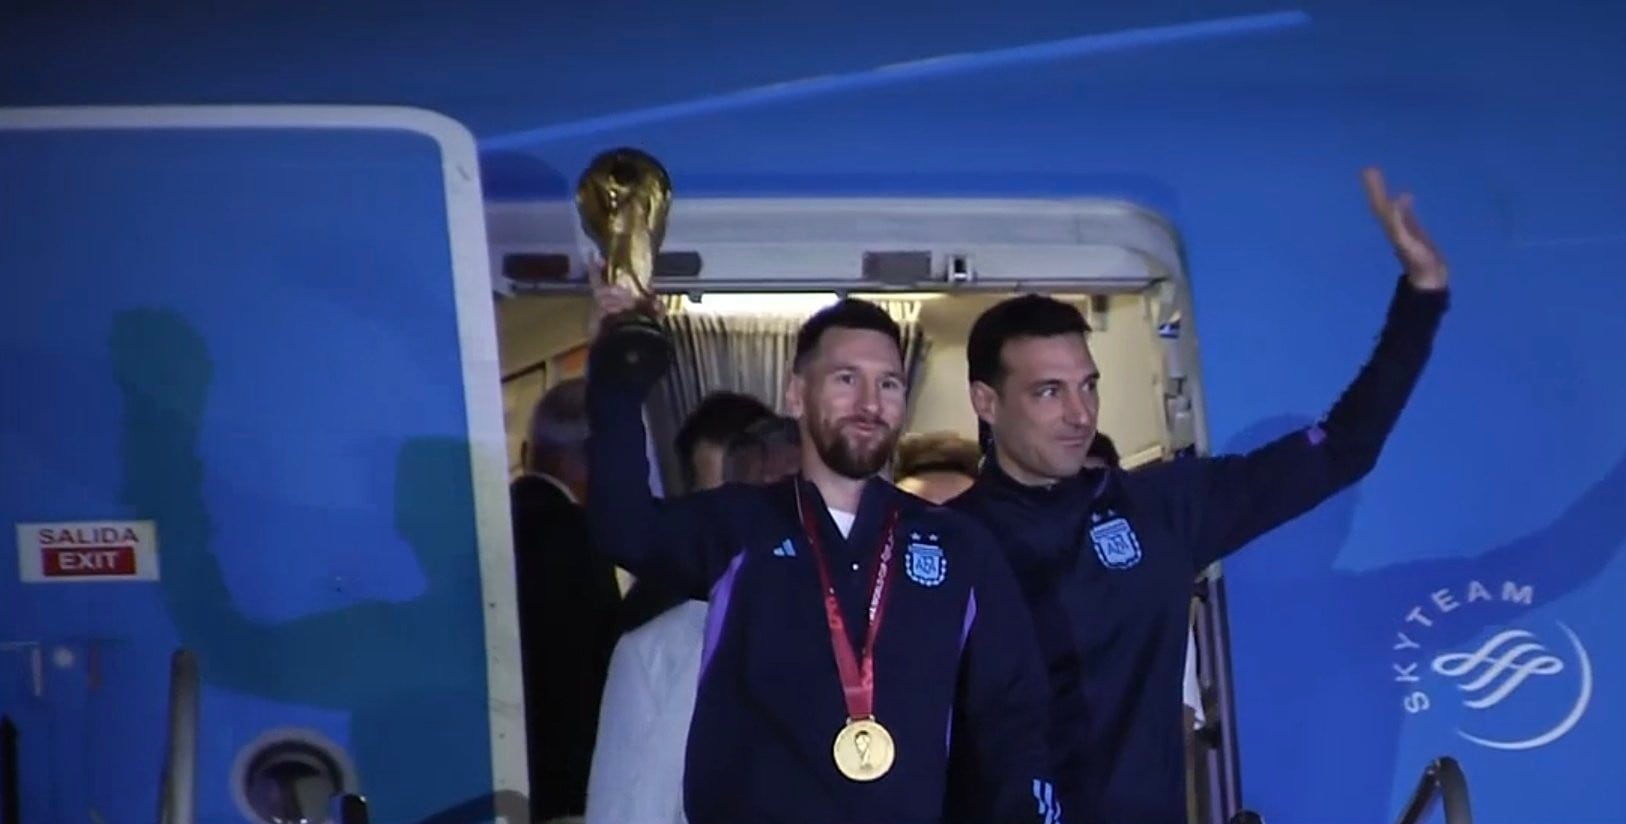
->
xmin=785 ymin=327 xmax=906 ymax=479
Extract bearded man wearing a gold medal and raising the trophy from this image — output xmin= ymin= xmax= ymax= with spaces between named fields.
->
xmin=587 ymin=288 xmax=1060 ymax=824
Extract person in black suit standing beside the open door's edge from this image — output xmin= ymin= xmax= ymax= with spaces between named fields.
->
xmin=509 ymin=379 xmax=621 ymax=821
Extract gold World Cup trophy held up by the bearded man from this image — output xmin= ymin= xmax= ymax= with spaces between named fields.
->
xmin=576 ymin=148 xmax=673 ymax=388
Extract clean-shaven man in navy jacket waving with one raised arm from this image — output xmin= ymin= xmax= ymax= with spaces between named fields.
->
xmin=951 ymin=169 xmax=1449 ymax=824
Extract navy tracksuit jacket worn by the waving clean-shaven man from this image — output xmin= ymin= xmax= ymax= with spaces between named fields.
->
xmin=950 ymin=280 xmax=1447 ymax=824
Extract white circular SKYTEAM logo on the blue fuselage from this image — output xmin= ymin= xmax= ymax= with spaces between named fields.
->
xmin=1393 ymin=580 xmax=1592 ymax=751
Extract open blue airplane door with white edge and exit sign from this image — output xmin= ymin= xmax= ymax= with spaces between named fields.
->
xmin=0 ymin=106 xmax=525 ymax=824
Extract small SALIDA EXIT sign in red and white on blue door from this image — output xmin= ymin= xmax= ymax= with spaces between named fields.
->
xmin=16 ymin=520 xmax=158 ymax=583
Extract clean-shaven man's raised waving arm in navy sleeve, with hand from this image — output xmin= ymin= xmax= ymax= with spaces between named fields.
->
xmin=1164 ymin=169 xmax=1449 ymax=569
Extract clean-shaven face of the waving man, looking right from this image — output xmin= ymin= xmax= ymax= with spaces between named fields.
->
xmin=971 ymin=333 xmax=1101 ymax=484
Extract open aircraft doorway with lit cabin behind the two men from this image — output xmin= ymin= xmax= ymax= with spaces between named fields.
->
xmin=486 ymin=193 xmax=1239 ymax=821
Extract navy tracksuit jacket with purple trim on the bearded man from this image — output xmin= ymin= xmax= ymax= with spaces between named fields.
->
xmin=587 ymin=368 xmax=1062 ymax=824
